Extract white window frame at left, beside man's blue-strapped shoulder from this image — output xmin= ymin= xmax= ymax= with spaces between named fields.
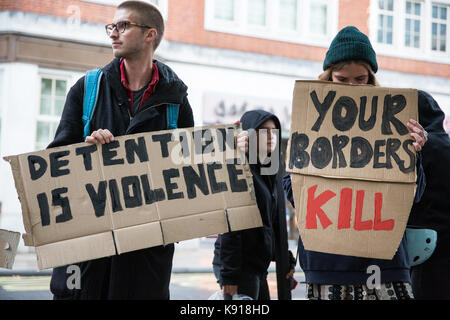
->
xmin=34 ymin=70 xmax=71 ymax=150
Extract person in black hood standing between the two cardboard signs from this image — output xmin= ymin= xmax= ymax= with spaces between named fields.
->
xmin=213 ymin=110 xmax=295 ymax=300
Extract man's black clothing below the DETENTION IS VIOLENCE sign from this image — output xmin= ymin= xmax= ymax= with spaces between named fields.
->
xmin=50 ymin=244 xmax=174 ymax=300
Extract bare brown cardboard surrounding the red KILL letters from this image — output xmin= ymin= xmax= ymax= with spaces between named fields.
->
xmin=291 ymin=174 xmax=415 ymax=260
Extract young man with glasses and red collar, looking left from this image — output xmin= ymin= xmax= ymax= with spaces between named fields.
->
xmin=48 ymin=1 xmax=194 ymax=299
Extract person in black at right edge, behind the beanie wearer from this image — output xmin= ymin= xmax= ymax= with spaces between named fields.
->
xmin=408 ymin=94 xmax=450 ymax=299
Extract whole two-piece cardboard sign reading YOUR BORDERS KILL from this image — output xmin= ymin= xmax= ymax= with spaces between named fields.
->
xmin=286 ymin=81 xmax=417 ymax=259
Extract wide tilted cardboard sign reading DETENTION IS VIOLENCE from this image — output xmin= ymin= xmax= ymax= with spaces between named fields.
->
xmin=5 ymin=126 xmax=262 ymax=269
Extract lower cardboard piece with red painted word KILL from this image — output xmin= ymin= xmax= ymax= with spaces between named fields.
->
xmin=291 ymin=174 xmax=415 ymax=260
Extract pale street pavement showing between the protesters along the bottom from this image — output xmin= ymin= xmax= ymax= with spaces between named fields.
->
xmin=0 ymin=238 xmax=305 ymax=300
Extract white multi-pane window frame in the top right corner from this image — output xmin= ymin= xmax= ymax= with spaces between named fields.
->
xmin=369 ymin=0 xmax=450 ymax=64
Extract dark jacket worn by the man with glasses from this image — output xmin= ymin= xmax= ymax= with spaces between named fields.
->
xmin=48 ymin=59 xmax=194 ymax=299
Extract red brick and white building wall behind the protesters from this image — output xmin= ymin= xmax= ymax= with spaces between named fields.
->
xmin=0 ymin=0 xmax=450 ymax=251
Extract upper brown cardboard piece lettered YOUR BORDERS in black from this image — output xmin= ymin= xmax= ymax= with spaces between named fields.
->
xmin=286 ymin=81 xmax=417 ymax=183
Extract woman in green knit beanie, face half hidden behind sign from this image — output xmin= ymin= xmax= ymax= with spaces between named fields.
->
xmin=283 ymin=26 xmax=442 ymax=300
